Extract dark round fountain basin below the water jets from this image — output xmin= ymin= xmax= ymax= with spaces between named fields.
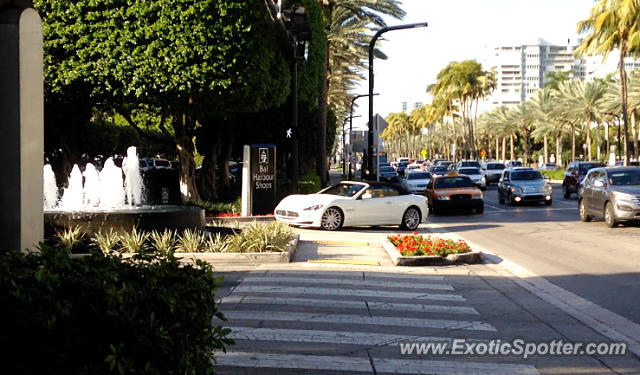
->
xmin=44 ymin=205 xmax=205 ymax=235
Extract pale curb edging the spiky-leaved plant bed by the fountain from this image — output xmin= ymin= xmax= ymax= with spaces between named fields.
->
xmin=174 ymin=234 xmax=300 ymax=264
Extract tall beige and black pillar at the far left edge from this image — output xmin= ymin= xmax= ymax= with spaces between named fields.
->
xmin=0 ymin=0 xmax=44 ymax=252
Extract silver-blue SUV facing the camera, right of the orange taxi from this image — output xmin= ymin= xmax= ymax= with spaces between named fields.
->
xmin=498 ymin=167 xmax=553 ymax=206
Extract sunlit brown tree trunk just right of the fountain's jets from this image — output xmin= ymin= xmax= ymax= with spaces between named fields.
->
xmin=172 ymin=114 xmax=200 ymax=203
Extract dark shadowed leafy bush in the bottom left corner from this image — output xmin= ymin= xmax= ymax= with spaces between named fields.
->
xmin=0 ymin=245 xmax=232 ymax=375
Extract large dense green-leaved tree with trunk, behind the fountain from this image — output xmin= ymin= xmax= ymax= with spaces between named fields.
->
xmin=34 ymin=0 xmax=289 ymax=200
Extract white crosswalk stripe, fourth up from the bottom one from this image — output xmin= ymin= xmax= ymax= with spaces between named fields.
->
xmin=220 ymin=295 xmax=479 ymax=315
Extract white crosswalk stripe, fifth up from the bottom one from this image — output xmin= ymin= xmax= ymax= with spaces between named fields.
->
xmin=233 ymin=284 xmax=465 ymax=301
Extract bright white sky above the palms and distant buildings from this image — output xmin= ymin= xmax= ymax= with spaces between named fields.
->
xmin=353 ymin=0 xmax=594 ymax=128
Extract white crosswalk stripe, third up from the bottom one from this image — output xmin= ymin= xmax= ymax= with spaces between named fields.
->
xmin=224 ymin=310 xmax=496 ymax=331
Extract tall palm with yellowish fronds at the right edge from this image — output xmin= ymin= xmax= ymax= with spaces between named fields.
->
xmin=576 ymin=0 xmax=640 ymax=165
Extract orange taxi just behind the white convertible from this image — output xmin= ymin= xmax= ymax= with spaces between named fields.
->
xmin=425 ymin=176 xmax=484 ymax=214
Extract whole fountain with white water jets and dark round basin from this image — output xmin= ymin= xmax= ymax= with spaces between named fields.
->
xmin=43 ymin=146 xmax=204 ymax=234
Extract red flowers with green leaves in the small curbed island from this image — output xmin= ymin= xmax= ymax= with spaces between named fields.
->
xmin=387 ymin=232 xmax=471 ymax=256
